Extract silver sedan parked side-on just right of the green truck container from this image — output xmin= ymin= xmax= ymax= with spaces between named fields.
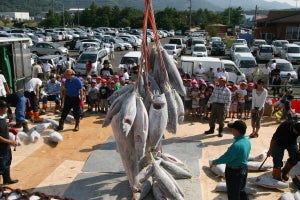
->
xmin=30 ymin=42 xmax=68 ymax=55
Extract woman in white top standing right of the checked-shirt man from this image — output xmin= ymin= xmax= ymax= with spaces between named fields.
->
xmin=249 ymin=79 xmax=268 ymax=138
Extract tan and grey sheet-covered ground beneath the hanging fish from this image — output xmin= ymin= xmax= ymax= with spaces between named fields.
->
xmin=5 ymin=111 xmax=300 ymax=200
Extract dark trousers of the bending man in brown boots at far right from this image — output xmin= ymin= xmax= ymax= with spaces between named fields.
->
xmin=272 ymin=144 xmax=298 ymax=168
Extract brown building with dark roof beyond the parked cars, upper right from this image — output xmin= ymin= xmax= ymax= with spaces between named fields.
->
xmin=254 ymin=10 xmax=300 ymax=42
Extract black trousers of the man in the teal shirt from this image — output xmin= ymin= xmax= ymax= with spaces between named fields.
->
xmin=225 ymin=165 xmax=248 ymax=200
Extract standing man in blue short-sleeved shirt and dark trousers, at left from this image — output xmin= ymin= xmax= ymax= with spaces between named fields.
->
xmin=55 ymin=69 xmax=83 ymax=131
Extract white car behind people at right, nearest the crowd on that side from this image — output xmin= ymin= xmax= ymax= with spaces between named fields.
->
xmin=267 ymin=58 xmax=298 ymax=82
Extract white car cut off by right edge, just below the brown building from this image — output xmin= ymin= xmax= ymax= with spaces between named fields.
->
xmin=281 ymin=44 xmax=300 ymax=63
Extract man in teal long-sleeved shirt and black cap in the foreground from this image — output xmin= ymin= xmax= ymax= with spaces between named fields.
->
xmin=210 ymin=120 xmax=251 ymax=200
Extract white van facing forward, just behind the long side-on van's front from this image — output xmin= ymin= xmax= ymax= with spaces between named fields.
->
xmin=235 ymin=54 xmax=257 ymax=81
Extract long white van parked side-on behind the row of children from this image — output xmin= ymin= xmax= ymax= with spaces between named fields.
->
xmin=181 ymin=56 xmax=246 ymax=83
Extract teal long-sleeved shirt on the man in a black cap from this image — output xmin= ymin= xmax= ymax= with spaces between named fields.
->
xmin=213 ymin=135 xmax=251 ymax=167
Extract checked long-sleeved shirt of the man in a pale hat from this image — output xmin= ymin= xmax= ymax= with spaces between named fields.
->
xmin=208 ymin=86 xmax=231 ymax=110
